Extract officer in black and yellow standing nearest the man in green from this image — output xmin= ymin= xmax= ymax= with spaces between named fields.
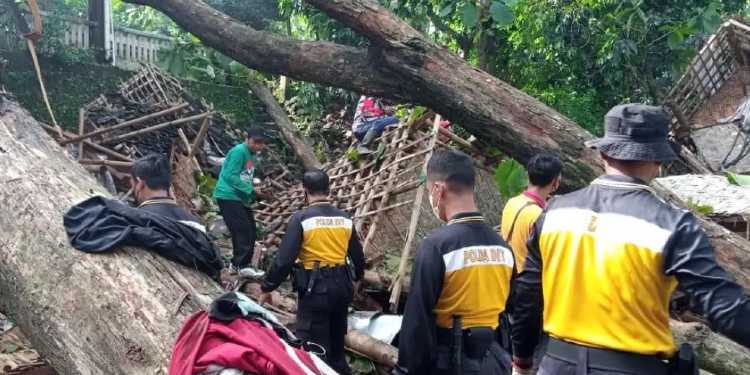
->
xmin=259 ymin=170 xmax=364 ymax=374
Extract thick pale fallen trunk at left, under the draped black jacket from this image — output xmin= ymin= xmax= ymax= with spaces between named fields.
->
xmin=0 ymin=94 xmax=220 ymax=374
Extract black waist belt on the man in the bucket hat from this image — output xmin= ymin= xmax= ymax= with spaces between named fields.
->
xmin=547 ymin=337 xmax=669 ymax=375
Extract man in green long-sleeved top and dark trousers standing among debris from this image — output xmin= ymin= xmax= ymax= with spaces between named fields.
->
xmin=213 ymin=129 xmax=267 ymax=271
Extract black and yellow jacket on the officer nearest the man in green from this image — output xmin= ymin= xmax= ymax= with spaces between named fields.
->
xmin=261 ymin=202 xmax=365 ymax=292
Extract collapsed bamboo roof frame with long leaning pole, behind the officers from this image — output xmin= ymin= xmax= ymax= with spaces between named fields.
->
xmin=253 ymin=114 xmax=502 ymax=310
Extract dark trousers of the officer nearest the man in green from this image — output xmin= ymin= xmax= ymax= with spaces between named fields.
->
xmin=296 ymin=267 xmax=354 ymax=374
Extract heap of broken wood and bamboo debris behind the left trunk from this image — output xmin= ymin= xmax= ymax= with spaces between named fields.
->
xmin=39 ymin=66 xmax=294 ymax=210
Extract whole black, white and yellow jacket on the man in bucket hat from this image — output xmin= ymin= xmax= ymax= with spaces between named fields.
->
xmin=512 ymin=175 xmax=750 ymax=358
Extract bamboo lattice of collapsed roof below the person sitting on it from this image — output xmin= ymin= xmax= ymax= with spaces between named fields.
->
xmin=254 ymin=119 xmax=484 ymax=264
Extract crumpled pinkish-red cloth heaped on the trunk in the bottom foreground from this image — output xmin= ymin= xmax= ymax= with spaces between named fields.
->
xmin=169 ymin=311 xmax=322 ymax=375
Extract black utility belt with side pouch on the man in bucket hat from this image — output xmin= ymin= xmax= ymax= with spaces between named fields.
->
xmin=547 ymin=337 xmax=698 ymax=375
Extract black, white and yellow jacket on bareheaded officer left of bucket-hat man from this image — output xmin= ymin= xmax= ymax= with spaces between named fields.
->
xmin=398 ymin=212 xmax=515 ymax=374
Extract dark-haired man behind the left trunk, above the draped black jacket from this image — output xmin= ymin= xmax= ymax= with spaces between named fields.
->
xmin=131 ymin=154 xmax=206 ymax=228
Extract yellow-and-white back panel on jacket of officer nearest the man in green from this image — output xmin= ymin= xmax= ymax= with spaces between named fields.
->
xmin=299 ymin=216 xmax=352 ymax=269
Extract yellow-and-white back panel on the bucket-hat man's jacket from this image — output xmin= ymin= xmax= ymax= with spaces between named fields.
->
xmin=539 ymin=208 xmax=677 ymax=356
